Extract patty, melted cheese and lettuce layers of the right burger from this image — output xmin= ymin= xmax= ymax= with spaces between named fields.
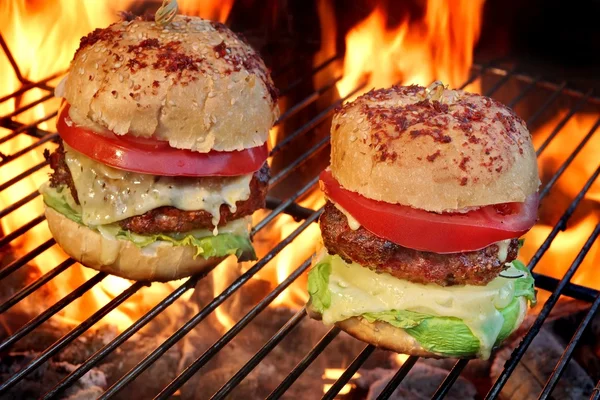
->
xmin=308 ymin=202 xmax=535 ymax=359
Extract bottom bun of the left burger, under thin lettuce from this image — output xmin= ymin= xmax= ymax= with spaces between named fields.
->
xmin=46 ymin=207 xmax=225 ymax=282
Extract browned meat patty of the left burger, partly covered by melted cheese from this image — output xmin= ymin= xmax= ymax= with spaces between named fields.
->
xmin=44 ymin=142 xmax=269 ymax=235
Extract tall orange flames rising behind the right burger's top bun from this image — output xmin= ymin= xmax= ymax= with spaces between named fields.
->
xmin=337 ymin=0 xmax=484 ymax=97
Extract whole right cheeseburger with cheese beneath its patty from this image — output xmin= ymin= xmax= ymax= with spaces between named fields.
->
xmin=308 ymin=82 xmax=539 ymax=359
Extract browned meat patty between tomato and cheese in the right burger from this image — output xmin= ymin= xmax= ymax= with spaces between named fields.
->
xmin=319 ymin=202 xmax=519 ymax=286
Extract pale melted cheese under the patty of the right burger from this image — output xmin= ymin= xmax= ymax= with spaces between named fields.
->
xmin=320 ymin=253 xmax=519 ymax=356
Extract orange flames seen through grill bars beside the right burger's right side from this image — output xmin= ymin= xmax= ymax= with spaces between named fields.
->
xmin=521 ymin=111 xmax=600 ymax=289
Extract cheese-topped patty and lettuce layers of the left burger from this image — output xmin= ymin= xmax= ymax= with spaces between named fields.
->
xmin=40 ymin=144 xmax=268 ymax=260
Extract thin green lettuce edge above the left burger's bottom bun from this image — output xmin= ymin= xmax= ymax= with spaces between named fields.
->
xmin=40 ymin=186 xmax=256 ymax=261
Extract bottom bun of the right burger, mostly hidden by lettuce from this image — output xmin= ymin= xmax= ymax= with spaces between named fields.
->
xmin=307 ymin=297 xmax=527 ymax=358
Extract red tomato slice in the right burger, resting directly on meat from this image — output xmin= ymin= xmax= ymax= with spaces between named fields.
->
xmin=320 ymin=170 xmax=539 ymax=254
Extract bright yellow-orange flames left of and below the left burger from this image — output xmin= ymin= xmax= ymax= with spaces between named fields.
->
xmin=0 ymin=0 xmax=202 ymax=329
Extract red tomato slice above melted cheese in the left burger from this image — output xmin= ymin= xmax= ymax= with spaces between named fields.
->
xmin=56 ymin=102 xmax=269 ymax=176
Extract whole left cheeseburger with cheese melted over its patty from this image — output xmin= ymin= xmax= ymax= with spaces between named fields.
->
xmin=40 ymin=16 xmax=278 ymax=281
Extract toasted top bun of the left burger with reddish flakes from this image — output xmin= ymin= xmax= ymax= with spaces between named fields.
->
xmin=65 ymin=16 xmax=279 ymax=153
